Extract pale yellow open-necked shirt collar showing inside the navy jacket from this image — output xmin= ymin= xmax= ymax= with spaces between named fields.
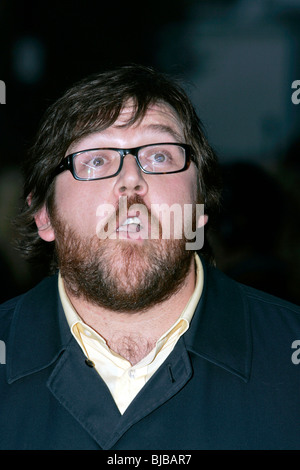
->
xmin=58 ymin=254 xmax=203 ymax=414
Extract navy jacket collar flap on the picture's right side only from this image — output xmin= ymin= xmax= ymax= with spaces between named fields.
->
xmin=184 ymin=259 xmax=252 ymax=382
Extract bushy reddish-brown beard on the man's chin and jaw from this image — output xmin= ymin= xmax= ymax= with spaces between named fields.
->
xmin=51 ymin=198 xmax=194 ymax=313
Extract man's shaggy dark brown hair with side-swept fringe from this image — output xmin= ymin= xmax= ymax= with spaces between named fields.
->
xmin=16 ymin=65 xmax=220 ymax=269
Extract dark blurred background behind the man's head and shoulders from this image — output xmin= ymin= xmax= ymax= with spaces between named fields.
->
xmin=0 ymin=0 xmax=300 ymax=303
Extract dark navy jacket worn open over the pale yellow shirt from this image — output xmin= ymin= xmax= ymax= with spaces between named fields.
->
xmin=0 ymin=267 xmax=300 ymax=450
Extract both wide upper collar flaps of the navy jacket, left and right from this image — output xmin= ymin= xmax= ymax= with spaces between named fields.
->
xmin=7 ymin=260 xmax=251 ymax=383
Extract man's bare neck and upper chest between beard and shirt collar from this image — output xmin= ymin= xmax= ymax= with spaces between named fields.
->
xmin=65 ymin=258 xmax=196 ymax=364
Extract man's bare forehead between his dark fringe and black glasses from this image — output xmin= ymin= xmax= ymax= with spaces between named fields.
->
xmin=67 ymin=102 xmax=184 ymax=153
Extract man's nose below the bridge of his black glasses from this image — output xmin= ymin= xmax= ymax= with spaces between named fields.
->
xmin=114 ymin=154 xmax=148 ymax=197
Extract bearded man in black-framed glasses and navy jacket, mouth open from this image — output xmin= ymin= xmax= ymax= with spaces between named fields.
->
xmin=0 ymin=66 xmax=300 ymax=450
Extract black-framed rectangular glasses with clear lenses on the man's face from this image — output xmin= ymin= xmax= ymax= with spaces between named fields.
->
xmin=53 ymin=142 xmax=192 ymax=181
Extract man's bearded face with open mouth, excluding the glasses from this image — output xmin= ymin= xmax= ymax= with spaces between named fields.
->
xmin=36 ymin=105 xmax=203 ymax=312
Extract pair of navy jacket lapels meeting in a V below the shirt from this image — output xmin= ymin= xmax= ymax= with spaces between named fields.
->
xmin=47 ymin=334 xmax=192 ymax=450
